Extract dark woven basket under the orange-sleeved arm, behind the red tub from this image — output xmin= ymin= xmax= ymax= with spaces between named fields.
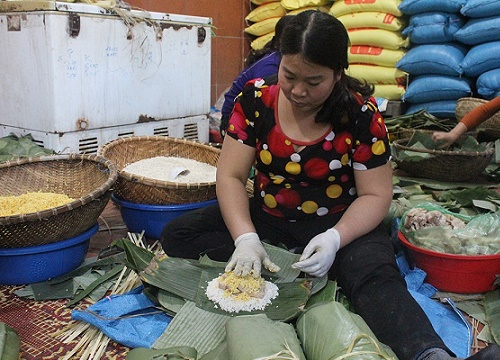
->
xmin=393 ymin=139 xmax=495 ymax=182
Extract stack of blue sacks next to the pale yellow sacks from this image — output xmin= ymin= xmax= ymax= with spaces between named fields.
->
xmin=396 ymin=0 xmax=473 ymax=118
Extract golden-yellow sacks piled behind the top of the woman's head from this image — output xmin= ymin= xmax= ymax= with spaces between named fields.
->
xmin=245 ymin=0 xmax=333 ymax=50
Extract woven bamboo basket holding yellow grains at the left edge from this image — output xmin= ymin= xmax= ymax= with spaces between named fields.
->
xmin=0 ymin=154 xmax=118 ymax=248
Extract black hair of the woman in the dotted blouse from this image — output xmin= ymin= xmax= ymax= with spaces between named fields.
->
xmin=279 ymin=10 xmax=373 ymax=128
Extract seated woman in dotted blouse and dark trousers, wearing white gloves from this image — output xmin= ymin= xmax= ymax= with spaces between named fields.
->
xmin=161 ymin=11 xmax=495 ymax=360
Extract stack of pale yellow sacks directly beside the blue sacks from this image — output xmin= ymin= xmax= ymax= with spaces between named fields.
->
xmin=329 ymin=0 xmax=409 ymax=100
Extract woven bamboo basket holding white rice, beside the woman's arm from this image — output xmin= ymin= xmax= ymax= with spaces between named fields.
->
xmin=99 ymin=136 xmax=220 ymax=205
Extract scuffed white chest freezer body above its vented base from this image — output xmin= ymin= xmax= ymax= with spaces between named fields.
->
xmin=0 ymin=1 xmax=211 ymax=138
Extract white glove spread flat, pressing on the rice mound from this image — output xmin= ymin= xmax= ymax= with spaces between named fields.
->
xmin=226 ymin=233 xmax=280 ymax=278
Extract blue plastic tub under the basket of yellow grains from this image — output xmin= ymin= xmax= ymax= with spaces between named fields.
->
xmin=0 ymin=223 xmax=99 ymax=285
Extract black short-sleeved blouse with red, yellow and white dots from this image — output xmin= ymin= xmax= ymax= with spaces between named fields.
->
xmin=227 ymin=80 xmax=390 ymax=221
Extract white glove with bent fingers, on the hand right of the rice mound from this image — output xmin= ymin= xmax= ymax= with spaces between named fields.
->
xmin=292 ymin=229 xmax=340 ymax=277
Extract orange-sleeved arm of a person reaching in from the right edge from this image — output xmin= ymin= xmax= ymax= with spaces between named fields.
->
xmin=432 ymin=96 xmax=500 ymax=148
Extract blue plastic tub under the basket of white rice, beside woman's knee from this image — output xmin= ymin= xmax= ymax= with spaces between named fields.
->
xmin=111 ymin=194 xmax=217 ymax=239
